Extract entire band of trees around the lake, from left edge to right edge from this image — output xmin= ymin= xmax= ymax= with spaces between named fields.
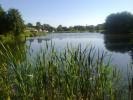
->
xmin=0 ymin=5 xmax=133 ymax=35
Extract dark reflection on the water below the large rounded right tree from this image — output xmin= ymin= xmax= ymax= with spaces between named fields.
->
xmin=104 ymin=34 xmax=133 ymax=63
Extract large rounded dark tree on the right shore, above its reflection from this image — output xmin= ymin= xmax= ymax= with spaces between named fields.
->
xmin=105 ymin=12 xmax=133 ymax=34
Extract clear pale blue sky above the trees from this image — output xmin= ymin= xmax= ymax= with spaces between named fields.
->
xmin=0 ymin=0 xmax=133 ymax=27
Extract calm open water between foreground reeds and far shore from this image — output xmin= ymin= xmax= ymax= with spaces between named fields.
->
xmin=26 ymin=33 xmax=133 ymax=71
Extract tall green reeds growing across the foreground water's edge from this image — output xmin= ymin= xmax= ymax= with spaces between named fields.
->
xmin=0 ymin=44 xmax=130 ymax=100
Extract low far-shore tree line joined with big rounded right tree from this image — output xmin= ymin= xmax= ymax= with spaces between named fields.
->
xmin=28 ymin=11 xmax=133 ymax=34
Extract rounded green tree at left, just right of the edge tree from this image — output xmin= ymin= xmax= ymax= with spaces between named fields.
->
xmin=7 ymin=9 xmax=25 ymax=35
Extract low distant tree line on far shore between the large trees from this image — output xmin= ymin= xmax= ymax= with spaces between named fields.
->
xmin=26 ymin=22 xmax=104 ymax=32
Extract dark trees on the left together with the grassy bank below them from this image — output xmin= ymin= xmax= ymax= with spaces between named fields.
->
xmin=0 ymin=6 xmax=45 ymax=43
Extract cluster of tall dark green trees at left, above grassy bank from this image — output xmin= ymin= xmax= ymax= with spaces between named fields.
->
xmin=0 ymin=6 xmax=25 ymax=35
